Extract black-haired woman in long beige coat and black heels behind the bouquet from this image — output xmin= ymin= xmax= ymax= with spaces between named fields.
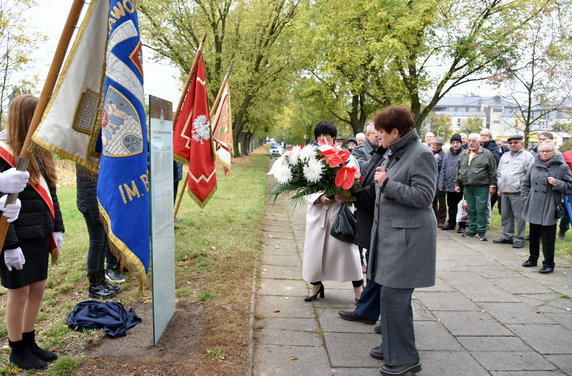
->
xmin=302 ymin=121 xmax=363 ymax=302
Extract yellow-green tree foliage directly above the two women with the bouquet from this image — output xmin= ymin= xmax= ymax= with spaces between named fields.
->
xmin=296 ymin=0 xmax=405 ymax=134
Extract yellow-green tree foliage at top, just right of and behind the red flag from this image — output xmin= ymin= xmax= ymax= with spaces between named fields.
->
xmin=139 ymin=0 xmax=300 ymax=154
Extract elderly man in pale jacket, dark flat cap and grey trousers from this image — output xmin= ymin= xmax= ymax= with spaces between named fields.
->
xmin=493 ymin=135 xmax=534 ymax=248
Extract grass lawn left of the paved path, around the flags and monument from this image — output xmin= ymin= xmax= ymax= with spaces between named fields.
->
xmin=0 ymin=150 xmax=268 ymax=375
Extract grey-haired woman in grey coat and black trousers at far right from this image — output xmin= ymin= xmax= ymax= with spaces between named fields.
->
xmin=521 ymin=142 xmax=572 ymax=274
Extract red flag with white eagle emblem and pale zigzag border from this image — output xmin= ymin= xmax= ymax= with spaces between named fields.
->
xmin=173 ymin=55 xmax=217 ymax=208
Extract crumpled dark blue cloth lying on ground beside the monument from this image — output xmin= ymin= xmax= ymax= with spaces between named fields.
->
xmin=66 ymin=300 xmax=141 ymax=338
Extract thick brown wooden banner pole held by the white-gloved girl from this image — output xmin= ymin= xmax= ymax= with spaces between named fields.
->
xmin=0 ymin=0 xmax=83 ymax=244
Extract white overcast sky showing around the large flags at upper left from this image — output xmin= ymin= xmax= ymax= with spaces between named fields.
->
xmin=25 ymin=0 xmax=182 ymax=109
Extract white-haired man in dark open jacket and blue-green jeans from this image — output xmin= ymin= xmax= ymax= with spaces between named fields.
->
xmin=455 ymin=133 xmax=497 ymax=241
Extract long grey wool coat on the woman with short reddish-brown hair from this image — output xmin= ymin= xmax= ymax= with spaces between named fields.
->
xmin=368 ymin=129 xmax=437 ymax=288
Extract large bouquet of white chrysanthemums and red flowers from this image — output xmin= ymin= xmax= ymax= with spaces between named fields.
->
xmin=268 ymin=142 xmax=360 ymax=201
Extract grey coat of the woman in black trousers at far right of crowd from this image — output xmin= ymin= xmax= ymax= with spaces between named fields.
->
xmin=520 ymin=152 xmax=572 ymax=226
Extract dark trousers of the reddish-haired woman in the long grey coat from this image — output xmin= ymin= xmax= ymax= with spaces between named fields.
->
xmin=380 ymin=286 xmax=419 ymax=366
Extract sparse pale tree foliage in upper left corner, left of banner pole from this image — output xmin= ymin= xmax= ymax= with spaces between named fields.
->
xmin=0 ymin=0 xmax=44 ymax=127
